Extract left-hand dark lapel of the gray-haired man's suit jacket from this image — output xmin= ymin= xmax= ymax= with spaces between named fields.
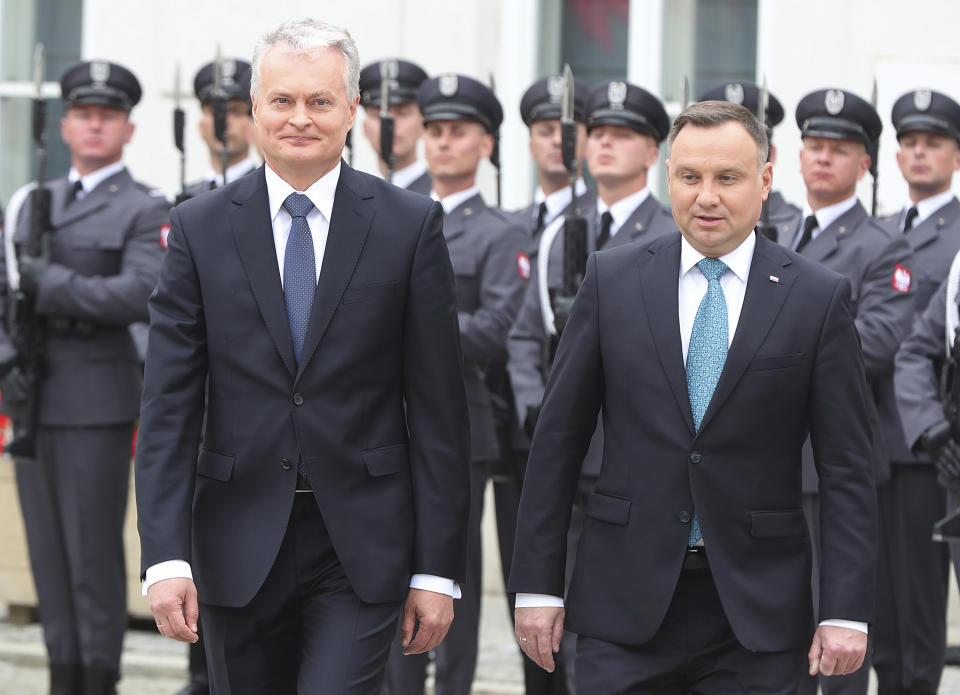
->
xmin=230 ymin=167 xmax=297 ymax=376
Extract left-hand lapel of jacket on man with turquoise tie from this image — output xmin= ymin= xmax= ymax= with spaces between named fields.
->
xmin=639 ymin=233 xmax=695 ymax=434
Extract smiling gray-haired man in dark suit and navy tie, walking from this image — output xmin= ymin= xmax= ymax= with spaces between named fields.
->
xmin=137 ymin=19 xmax=469 ymax=695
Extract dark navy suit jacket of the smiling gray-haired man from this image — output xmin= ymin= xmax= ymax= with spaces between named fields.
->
xmin=136 ymin=164 xmax=469 ymax=606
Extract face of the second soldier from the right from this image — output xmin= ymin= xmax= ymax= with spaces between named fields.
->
xmin=800 ymin=137 xmax=870 ymax=208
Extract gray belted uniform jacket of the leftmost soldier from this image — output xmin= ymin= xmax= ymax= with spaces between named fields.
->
xmin=0 ymin=169 xmax=170 ymax=427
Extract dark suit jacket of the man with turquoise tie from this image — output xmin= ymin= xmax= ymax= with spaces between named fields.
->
xmin=509 ymin=234 xmax=876 ymax=651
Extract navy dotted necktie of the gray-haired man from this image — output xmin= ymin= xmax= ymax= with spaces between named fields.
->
xmin=283 ymin=193 xmax=317 ymax=364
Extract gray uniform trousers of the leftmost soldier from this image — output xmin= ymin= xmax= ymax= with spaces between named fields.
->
xmin=16 ymin=423 xmax=133 ymax=671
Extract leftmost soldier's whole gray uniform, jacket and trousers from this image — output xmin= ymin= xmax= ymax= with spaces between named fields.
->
xmin=0 ymin=170 xmax=169 ymax=671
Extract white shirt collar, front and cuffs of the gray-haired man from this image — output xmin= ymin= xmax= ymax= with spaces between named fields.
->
xmin=142 ymin=162 xmax=460 ymax=598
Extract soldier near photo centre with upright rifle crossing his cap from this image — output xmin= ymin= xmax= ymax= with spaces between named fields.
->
xmin=516 ymin=75 xmax=596 ymax=254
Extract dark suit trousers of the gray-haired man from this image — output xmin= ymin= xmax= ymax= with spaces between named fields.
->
xmin=200 ymin=492 xmax=401 ymax=695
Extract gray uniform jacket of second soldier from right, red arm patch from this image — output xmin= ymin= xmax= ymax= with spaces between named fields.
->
xmin=780 ymin=202 xmax=915 ymax=492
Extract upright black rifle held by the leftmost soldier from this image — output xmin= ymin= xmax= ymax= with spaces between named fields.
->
xmin=3 ymin=44 xmax=53 ymax=462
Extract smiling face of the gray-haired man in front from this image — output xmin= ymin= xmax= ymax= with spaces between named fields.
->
xmin=253 ymin=47 xmax=360 ymax=178
